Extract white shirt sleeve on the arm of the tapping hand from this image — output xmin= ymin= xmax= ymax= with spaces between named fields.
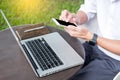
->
xmin=78 ymin=0 xmax=97 ymax=21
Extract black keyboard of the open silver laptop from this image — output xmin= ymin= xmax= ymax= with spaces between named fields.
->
xmin=23 ymin=38 xmax=63 ymax=71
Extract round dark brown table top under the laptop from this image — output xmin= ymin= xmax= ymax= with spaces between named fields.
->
xmin=0 ymin=27 xmax=84 ymax=80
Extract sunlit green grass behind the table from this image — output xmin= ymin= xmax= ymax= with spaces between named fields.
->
xmin=0 ymin=0 xmax=83 ymax=30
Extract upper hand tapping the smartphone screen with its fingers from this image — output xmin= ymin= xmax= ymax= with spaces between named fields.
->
xmin=59 ymin=10 xmax=88 ymax=25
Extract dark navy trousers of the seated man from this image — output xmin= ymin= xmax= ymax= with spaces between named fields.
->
xmin=69 ymin=43 xmax=120 ymax=80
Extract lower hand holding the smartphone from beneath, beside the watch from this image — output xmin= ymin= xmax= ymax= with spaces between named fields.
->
xmin=65 ymin=26 xmax=93 ymax=41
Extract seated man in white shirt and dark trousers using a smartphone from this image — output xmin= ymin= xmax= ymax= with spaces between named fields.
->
xmin=60 ymin=0 xmax=120 ymax=80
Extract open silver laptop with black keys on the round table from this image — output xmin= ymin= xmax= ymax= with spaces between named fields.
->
xmin=0 ymin=10 xmax=84 ymax=77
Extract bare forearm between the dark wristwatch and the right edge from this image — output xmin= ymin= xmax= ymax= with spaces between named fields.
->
xmin=97 ymin=37 xmax=120 ymax=55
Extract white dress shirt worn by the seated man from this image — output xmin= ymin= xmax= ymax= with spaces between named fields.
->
xmin=80 ymin=0 xmax=120 ymax=61
